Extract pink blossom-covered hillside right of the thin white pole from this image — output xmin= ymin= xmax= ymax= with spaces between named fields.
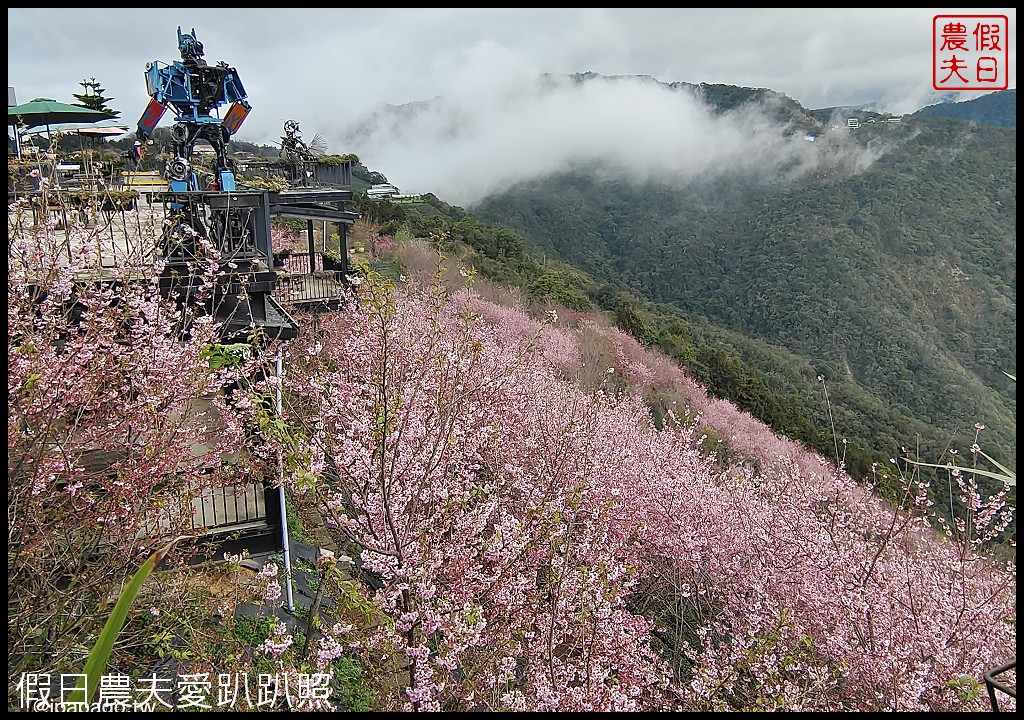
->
xmin=272 ymin=256 xmax=1016 ymax=711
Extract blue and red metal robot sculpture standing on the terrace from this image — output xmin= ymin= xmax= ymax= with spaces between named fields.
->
xmin=135 ymin=27 xmax=252 ymax=192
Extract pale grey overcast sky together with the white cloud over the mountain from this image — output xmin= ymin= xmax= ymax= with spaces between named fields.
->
xmin=7 ymin=7 xmax=1017 ymax=205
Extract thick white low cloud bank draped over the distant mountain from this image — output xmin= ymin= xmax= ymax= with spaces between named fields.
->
xmin=333 ymin=76 xmax=879 ymax=207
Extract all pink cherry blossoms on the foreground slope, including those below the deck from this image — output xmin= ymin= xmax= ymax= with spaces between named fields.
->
xmin=7 ymin=201 xmax=1017 ymax=712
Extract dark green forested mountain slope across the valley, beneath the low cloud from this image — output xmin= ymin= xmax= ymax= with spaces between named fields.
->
xmin=471 ymin=118 xmax=1016 ymax=495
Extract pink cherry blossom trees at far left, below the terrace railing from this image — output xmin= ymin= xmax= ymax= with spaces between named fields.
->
xmin=7 ymin=204 xmax=254 ymax=689
